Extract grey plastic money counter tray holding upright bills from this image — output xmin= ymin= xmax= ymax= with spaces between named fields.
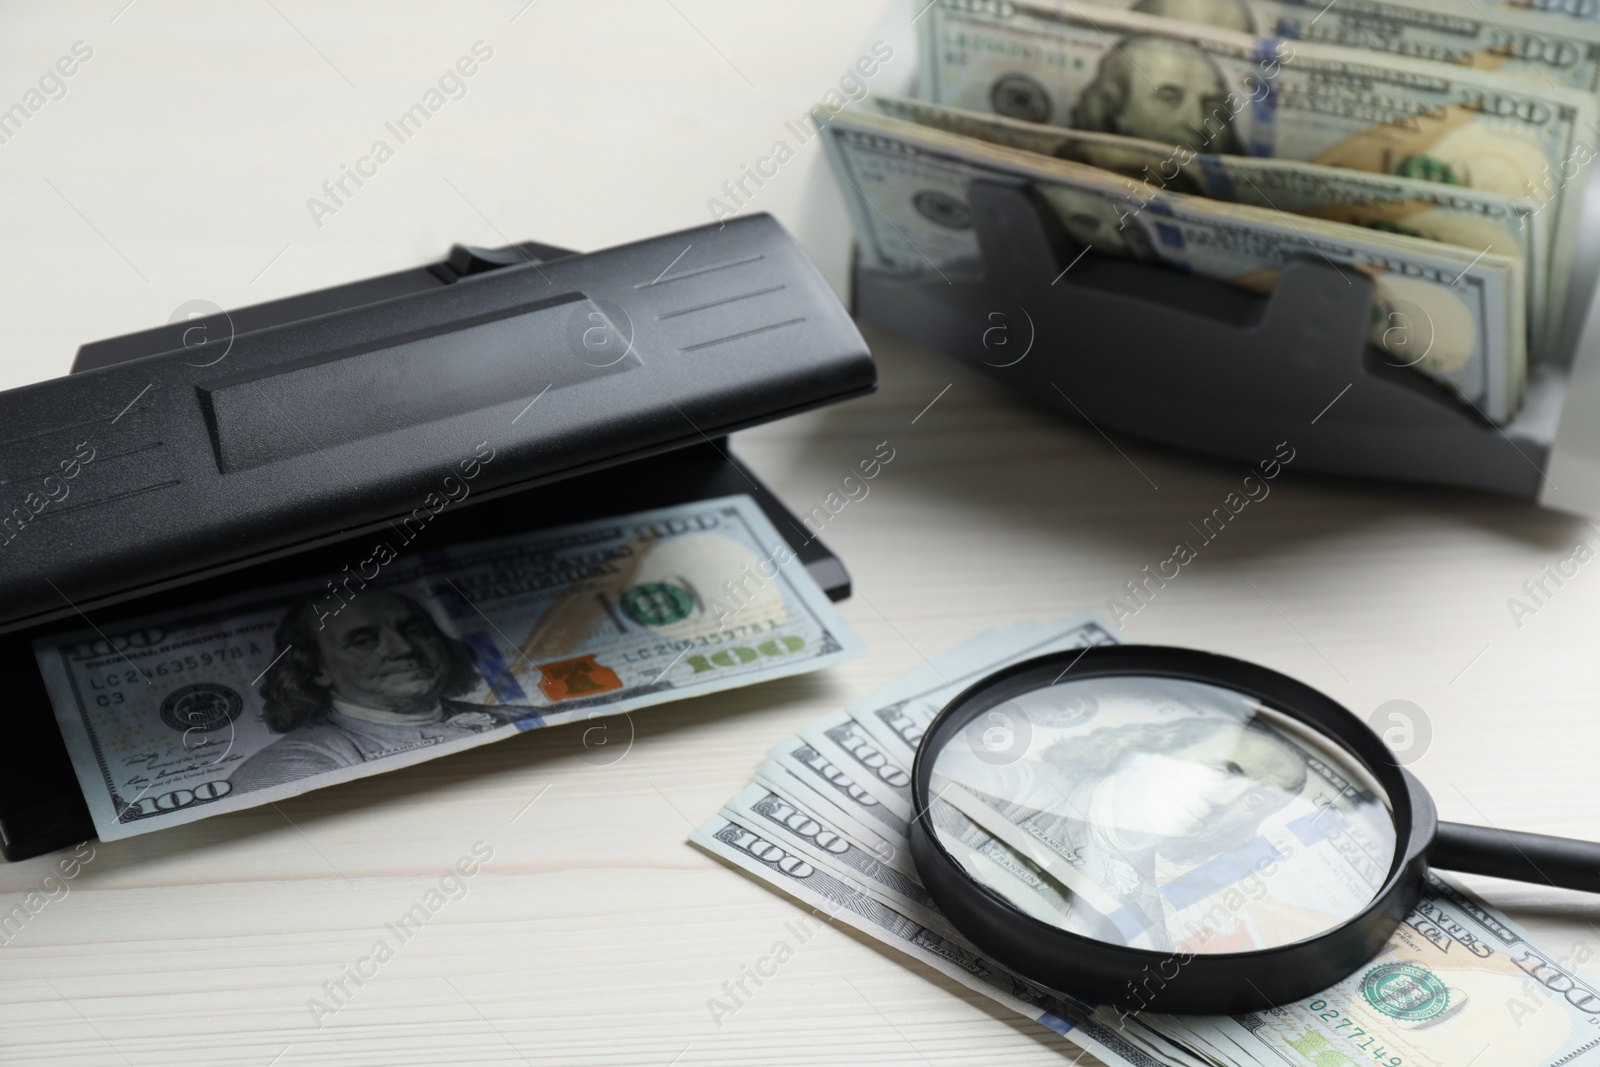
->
xmin=853 ymin=179 xmax=1600 ymax=517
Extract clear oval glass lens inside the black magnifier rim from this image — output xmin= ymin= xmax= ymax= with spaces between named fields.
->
xmin=928 ymin=677 xmax=1395 ymax=953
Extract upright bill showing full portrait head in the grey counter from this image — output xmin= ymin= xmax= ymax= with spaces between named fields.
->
xmin=918 ymin=0 xmax=1600 ymax=358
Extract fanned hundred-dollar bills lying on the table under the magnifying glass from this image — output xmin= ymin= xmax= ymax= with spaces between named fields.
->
xmin=690 ymin=616 xmax=1600 ymax=1067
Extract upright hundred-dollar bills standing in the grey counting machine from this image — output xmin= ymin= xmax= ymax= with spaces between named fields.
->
xmin=826 ymin=0 xmax=1600 ymax=422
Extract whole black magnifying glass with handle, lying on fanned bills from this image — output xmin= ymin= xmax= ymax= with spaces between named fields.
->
xmin=910 ymin=645 xmax=1600 ymax=1014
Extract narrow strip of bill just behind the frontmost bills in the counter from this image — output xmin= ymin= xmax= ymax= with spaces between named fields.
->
xmin=867 ymin=93 xmax=1555 ymax=352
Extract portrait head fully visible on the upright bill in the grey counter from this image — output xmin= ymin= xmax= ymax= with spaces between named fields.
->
xmin=1069 ymin=35 xmax=1243 ymax=155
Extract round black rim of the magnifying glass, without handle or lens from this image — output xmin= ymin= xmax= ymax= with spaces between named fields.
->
xmin=910 ymin=645 xmax=1437 ymax=1014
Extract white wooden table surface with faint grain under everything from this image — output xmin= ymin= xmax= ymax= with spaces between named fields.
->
xmin=0 ymin=0 xmax=1600 ymax=1067
